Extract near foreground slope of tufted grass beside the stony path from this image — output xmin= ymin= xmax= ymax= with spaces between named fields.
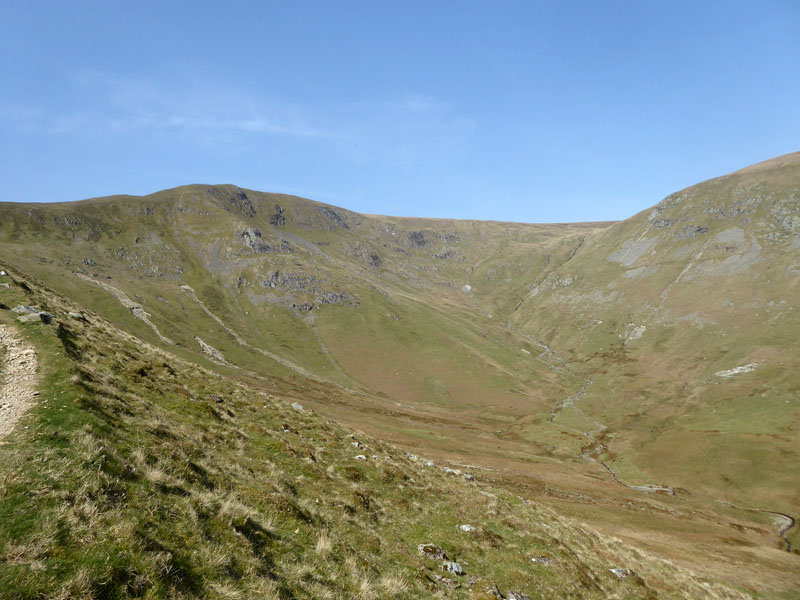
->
xmin=0 ymin=265 xmax=743 ymax=600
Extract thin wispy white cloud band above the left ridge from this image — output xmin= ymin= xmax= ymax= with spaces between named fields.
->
xmin=0 ymin=71 xmax=475 ymax=166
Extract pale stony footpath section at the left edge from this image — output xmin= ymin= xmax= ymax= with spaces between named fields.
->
xmin=0 ymin=325 xmax=36 ymax=438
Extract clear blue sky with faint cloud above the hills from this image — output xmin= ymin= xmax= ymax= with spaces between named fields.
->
xmin=0 ymin=0 xmax=800 ymax=222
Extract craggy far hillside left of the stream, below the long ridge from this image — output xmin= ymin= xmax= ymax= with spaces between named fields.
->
xmin=0 ymin=186 xmax=607 ymax=474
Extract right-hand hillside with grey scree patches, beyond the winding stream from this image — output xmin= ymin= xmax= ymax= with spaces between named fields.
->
xmin=510 ymin=153 xmax=800 ymax=535
